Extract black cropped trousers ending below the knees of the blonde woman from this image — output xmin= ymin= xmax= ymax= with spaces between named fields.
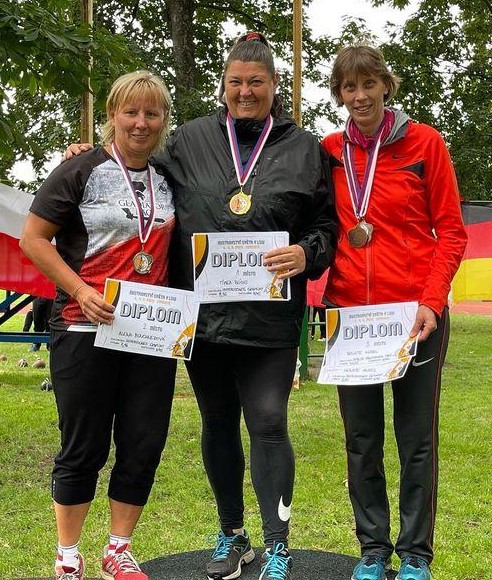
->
xmin=50 ymin=332 xmax=176 ymax=505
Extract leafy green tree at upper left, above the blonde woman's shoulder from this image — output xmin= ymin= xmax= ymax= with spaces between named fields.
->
xmin=0 ymin=0 xmax=142 ymax=181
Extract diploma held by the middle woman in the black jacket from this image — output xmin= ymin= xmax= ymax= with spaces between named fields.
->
xmin=192 ymin=232 xmax=290 ymax=302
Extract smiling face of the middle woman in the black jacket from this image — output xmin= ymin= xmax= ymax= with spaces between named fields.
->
xmin=224 ymin=60 xmax=278 ymax=121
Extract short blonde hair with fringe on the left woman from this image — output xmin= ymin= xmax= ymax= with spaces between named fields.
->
xmin=101 ymin=70 xmax=171 ymax=151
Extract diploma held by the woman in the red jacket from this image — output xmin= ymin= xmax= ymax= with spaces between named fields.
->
xmin=318 ymin=302 xmax=418 ymax=385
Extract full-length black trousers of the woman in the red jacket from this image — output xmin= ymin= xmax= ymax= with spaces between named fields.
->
xmin=338 ymin=308 xmax=449 ymax=562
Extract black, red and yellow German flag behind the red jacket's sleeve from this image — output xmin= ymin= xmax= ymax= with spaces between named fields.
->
xmin=452 ymin=201 xmax=492 ymax=302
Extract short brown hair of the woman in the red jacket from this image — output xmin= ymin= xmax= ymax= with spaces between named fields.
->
xmin=330 ymin=44 xmax=401 ymax=107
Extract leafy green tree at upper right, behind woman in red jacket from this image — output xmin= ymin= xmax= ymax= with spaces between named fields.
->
xmin=373 ymin=0 xmax=492 ymax=200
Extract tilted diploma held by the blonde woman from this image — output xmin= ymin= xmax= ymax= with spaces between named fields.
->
xmin=94 ymin=278 xmax=200 ymax=360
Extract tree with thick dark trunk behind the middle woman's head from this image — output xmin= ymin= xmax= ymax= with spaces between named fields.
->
xmin=93 ymin=0 xmax=336 ymax=124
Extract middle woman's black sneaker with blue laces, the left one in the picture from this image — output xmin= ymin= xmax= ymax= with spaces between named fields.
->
xmin=207 ymin=530 xmax=255 ymax=580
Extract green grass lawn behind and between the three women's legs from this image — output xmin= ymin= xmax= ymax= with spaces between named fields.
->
xmin=0 ymin=315 xmax=492 ymax=580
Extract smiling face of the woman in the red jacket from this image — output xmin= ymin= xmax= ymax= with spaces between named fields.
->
xmin=340 ymin=75 xmax=388 ymax=135
